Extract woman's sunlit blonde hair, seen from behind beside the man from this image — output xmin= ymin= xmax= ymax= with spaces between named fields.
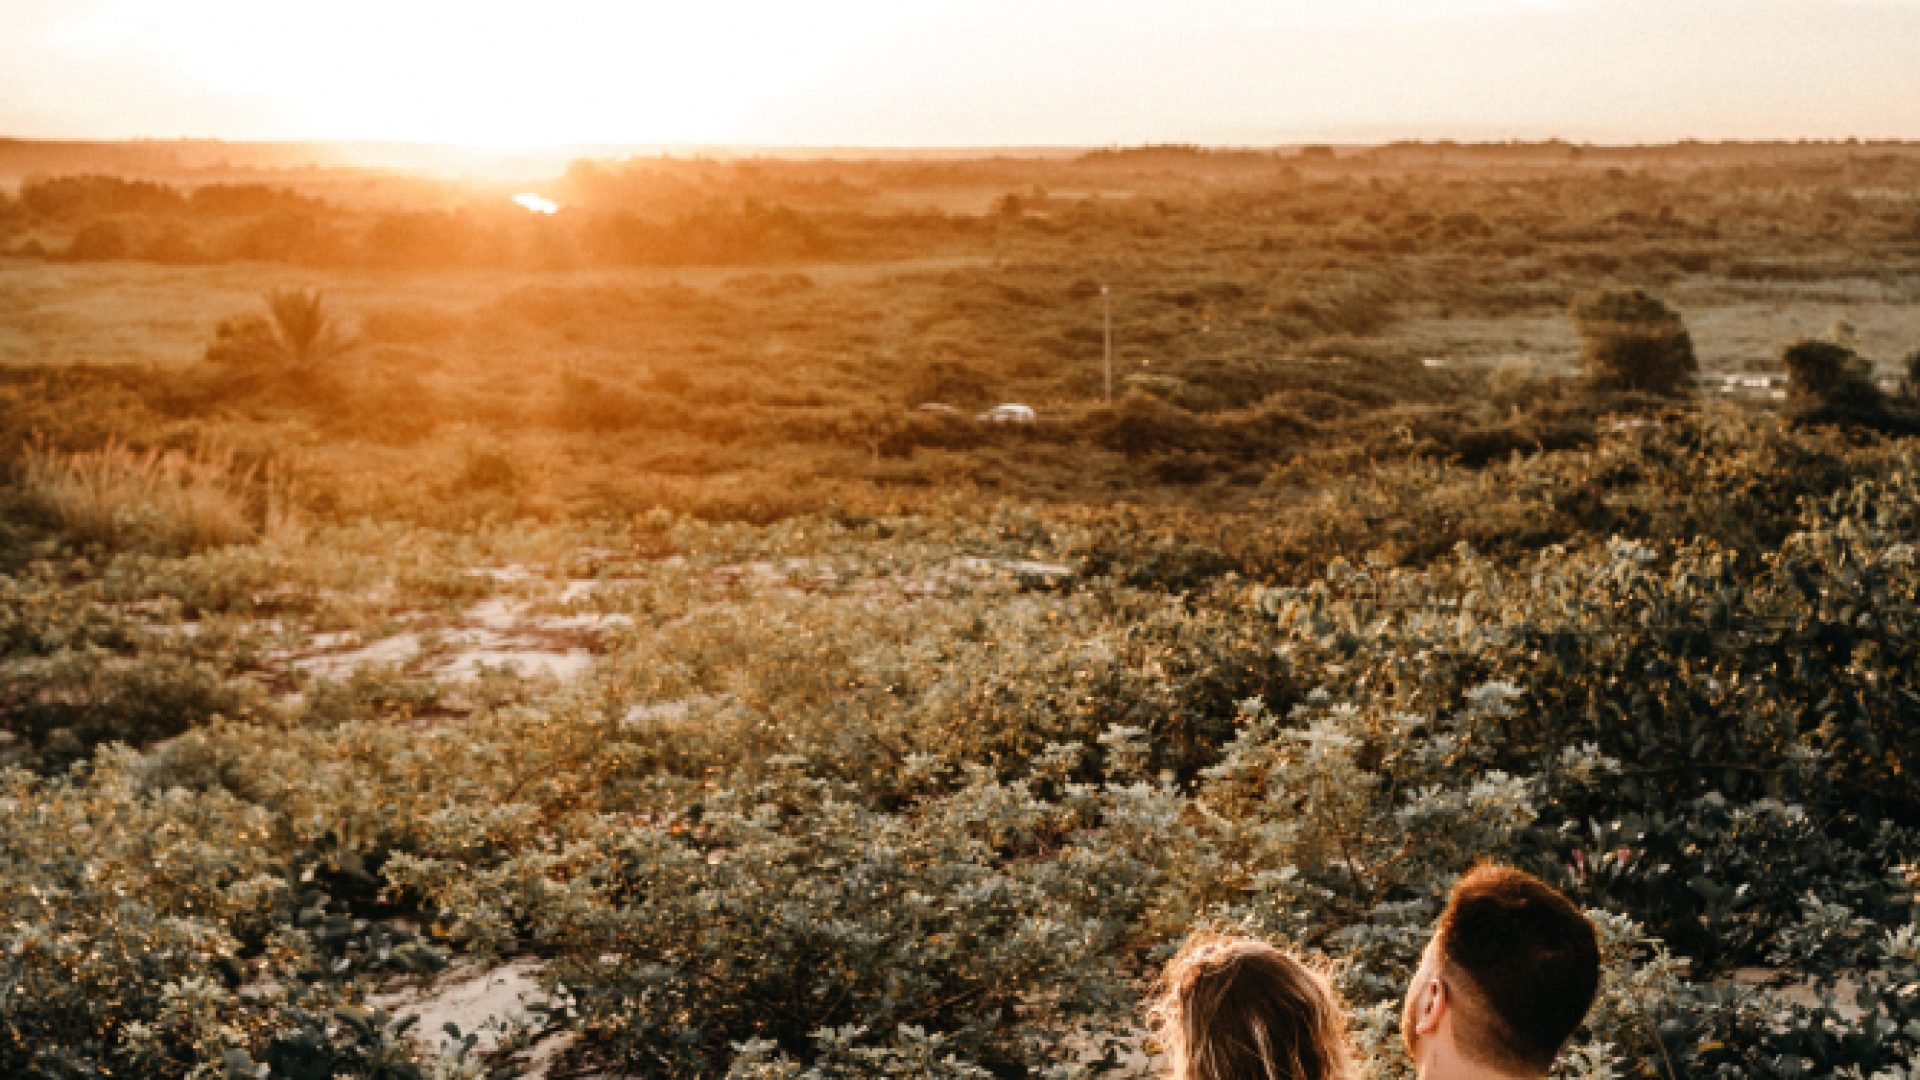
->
xmin=1148 ymin=934 xmax=1357 ymax=1080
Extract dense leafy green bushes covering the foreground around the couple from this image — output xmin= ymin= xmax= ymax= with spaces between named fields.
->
xmin=11 ymin=401 xmax=1920 ymax=1076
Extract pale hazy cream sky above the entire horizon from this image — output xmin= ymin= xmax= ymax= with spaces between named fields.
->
xmin=0 ymin=0 xmax=1920 ymax=146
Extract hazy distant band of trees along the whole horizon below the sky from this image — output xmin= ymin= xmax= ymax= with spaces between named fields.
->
xmin=11 ymin=144 xmax=1920 ymax=270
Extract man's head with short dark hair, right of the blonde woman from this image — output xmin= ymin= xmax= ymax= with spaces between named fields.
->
xmin=1402 ymin=867 xmax=1599 ymax=1076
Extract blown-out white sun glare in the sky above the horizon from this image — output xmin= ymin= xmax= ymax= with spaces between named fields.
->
xmin=46 ymin=0 xmax=929 ymax=148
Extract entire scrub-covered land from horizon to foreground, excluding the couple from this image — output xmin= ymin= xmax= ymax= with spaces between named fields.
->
xmin=0 ymin=144 xmax=1920 ymax=1078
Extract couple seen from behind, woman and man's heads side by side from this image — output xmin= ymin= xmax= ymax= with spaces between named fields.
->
xmin=1154 ymin=867 xmax=1599 ymax=1080
